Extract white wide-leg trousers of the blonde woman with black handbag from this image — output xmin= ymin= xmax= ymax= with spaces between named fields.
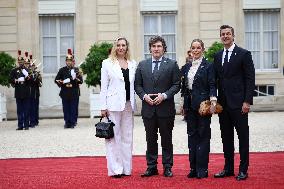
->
xmin=105 ymin=101 xmax=134 ymax=176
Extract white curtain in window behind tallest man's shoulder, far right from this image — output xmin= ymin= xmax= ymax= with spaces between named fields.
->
xmin=245 ymin=10 xmax=280 ymax=70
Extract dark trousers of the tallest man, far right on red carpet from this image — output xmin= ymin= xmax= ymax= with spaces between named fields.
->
xmin=219 ymin=107 xmax=249 ymax=173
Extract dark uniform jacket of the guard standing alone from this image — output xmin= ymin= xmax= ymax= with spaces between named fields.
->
xmin=54 ymin=66 xmax=83 ymax=99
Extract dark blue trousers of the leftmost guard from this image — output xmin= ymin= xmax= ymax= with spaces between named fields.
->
xmin=16 ymin=98 xmax=30 ymax=129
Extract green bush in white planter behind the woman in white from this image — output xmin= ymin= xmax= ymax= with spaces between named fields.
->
xmin=80 ymin=42 xmax=112 ymax=118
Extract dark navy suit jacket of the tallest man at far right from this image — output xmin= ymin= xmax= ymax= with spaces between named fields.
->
xmin=214 ymin=45 xmax=255 ymax=109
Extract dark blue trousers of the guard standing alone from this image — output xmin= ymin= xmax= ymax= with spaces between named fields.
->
xmin=62 ymin=98 xmax=76 ymax=126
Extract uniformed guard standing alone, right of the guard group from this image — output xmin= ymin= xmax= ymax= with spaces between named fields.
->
xmin=55 ymin=49 xmax=83 ymax=128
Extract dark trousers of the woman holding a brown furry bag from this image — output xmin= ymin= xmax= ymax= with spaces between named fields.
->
xmin=187 ymin=109 xmax=211 ymax=176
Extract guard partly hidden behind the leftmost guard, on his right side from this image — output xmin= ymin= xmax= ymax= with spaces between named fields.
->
xmin=30 ymin=55 xmax=42 ymax=127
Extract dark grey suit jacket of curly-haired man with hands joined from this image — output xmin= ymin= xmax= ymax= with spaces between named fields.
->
xmin=134 ymin=57 xmax=180 ymax=118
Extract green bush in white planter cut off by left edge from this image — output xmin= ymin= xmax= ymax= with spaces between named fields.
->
xmin=0 ymin=52 xmax=16 ymax=121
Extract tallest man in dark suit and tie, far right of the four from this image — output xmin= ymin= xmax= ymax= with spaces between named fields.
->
xmin=214 ymin=25 xmax=255 ymax=180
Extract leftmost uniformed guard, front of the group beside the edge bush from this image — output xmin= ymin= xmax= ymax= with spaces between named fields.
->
xmin=10 ymin=50 xmax=30 ymax=130
